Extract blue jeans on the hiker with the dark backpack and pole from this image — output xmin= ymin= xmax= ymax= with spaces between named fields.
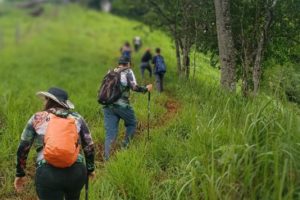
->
xmin=103 ymin=106 xmax=136 ymax=160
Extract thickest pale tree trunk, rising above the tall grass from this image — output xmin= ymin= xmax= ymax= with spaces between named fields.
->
xmin=214 ymin=0 xmax=236 ymax=92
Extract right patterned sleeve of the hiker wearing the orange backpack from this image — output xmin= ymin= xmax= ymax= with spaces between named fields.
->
xmin=79 ymin=118 xmax=95 ymax=174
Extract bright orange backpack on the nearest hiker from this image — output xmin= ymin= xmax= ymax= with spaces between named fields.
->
xmin=44 ymin=114 xmax=80 ymax=168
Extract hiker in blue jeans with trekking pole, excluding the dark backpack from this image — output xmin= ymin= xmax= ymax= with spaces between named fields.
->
xmin=103 ymin=57 xmax=152 ymax=160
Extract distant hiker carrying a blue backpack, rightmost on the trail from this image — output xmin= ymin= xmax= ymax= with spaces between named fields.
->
xmin=152 ymin=48 xmax=166 ymax=92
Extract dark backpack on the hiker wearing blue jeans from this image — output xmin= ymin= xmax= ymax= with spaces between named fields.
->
xmin=98 ymin=67 xmax=129 ymax=105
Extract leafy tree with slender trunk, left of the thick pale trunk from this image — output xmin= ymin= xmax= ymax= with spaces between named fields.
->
xmin=114 ymin=0 xmax=206 ymax=78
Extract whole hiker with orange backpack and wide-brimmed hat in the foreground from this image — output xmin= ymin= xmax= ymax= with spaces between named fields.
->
xmin=14 ymin=87 xmax=95 ymax=200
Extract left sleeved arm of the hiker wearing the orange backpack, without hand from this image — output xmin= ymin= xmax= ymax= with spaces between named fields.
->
xmin=16 ymin=116 xmax=36 ymax=177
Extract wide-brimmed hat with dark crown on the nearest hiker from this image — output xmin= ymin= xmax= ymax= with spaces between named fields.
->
xmin=36 ymin=87 xmax=75 ymax=109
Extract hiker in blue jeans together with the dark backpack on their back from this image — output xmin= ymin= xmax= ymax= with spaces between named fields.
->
xmin=98 ymin=57 xmax=152 ymax=160
